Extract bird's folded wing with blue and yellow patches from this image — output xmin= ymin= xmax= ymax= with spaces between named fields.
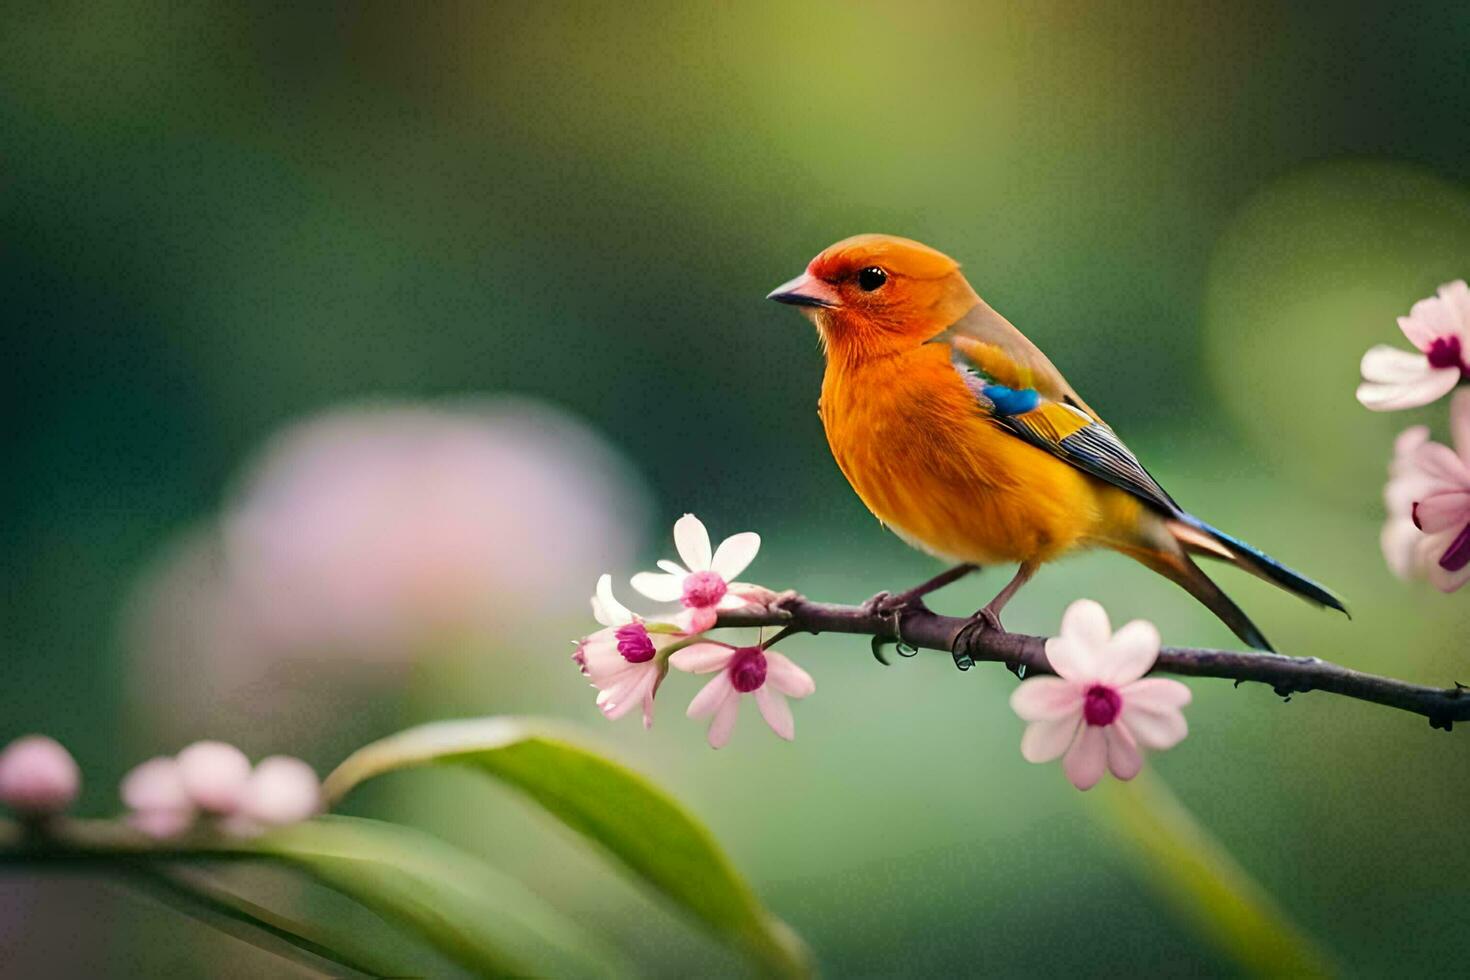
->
xmin=952 ymin=327 xmax=1183 ymax=514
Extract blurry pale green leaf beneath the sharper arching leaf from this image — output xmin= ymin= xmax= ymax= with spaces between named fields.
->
xmin=245 ymin=817 xmax=628 ymax=977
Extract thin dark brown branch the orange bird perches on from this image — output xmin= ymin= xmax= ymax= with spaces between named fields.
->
xmin=717 ymin=594 xmax=1470 ymax=732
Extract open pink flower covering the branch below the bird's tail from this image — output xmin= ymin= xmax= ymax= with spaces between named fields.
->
xmin=1011 ymin=599 xmax=1189 ymax=789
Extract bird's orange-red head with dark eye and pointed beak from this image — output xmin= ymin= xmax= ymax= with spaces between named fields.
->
xmin=766 ymin=235 xmax=980 ymax=356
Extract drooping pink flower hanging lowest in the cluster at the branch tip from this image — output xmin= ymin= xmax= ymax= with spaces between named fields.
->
xmin=669 ymin=641 xmax=817 ymax=748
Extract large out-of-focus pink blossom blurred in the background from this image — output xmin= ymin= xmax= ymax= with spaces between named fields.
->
xmin=123 ymin=398 xmax=647 ymax=749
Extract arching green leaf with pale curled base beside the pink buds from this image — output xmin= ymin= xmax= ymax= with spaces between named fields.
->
xmin=323 ymin=718 xmax=811 ymax=976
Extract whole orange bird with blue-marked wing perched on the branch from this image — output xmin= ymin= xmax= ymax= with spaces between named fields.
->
xmin=769 ymin=235 xmax=1347 ymax=651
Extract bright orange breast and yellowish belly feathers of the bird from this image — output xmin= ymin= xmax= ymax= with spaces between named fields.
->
xmin=822 ymin=344 xmax=1119 ymax=564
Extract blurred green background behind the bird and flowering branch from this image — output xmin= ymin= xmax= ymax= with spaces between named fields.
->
xmin=0 ymin=1 xmax=1470 ymax=976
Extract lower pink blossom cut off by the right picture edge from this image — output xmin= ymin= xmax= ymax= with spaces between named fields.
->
xmin=1382 ymin=391 xmax=1470 ymax=592
